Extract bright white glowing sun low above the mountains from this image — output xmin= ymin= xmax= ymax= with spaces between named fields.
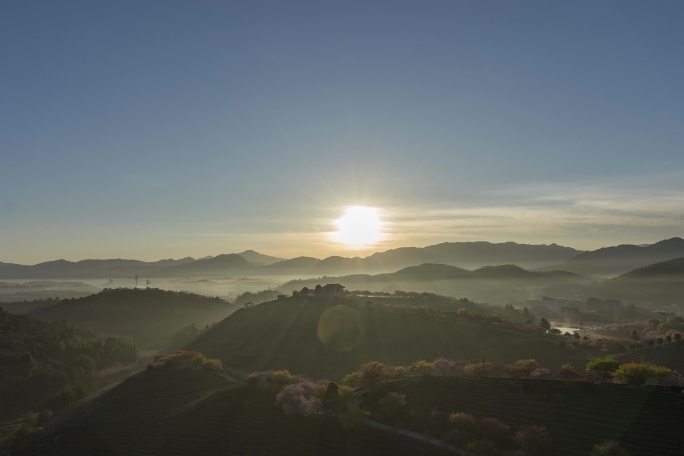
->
xmin=333 ymin=206 xmax=382 ymax=247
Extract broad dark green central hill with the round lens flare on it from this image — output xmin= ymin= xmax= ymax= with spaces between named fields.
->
xmin=188 ymin=295 xmax=590 ymax=378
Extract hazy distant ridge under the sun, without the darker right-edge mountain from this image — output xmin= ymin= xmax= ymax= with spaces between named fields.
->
xmin=0 ymin=241 xmax=580 ymax=279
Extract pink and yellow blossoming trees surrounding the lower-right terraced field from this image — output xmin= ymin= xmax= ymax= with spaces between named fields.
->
xmin=256 ymin=358 xmax=656 ymax=456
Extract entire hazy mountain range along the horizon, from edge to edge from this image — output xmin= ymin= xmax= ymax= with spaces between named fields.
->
xmin=0 ymin=237 xmax=684 ymax=279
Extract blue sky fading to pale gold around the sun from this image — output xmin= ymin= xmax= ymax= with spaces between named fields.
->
xmin=0 ymin=0 xmax=684 ymax=263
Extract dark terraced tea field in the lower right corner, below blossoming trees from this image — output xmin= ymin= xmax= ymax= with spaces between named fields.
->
xmin=376 ymin=377 xmax=684 ymax=456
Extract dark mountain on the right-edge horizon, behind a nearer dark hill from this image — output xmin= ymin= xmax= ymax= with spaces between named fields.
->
xmin=555 ymin=237 xmax=684 ymax=275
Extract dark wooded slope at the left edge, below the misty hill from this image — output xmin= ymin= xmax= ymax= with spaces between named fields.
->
xmin=0 ymin=310 xmax=137 ymax=414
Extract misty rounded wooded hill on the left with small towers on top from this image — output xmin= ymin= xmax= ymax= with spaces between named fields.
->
xmin=31 ymin=288 xmax=232 ymax=348
